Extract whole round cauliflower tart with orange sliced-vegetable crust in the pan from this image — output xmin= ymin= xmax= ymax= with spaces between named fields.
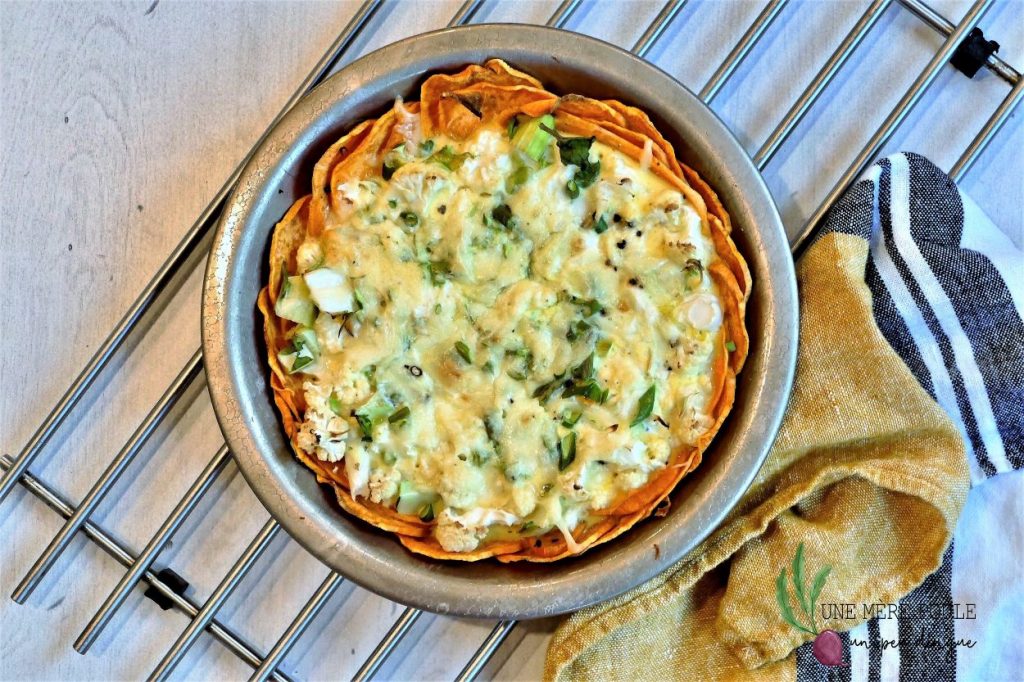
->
xmin=259 ymin=59 xmax=751 ymax=561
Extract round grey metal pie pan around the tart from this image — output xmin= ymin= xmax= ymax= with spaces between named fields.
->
xmin=203 ymin=25 xmax=798 ymax=619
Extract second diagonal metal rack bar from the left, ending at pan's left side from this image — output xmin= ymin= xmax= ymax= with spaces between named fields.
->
xmin=11 ymin=351 xmax=203 ymax=604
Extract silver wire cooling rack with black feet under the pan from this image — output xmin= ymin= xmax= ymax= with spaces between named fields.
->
xmin=0 ymin=0 xmax=1024 ymax=680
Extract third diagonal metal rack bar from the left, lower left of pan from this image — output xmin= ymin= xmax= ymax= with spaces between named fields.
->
xmin=75 ymin=445 xmax=231 ymax=653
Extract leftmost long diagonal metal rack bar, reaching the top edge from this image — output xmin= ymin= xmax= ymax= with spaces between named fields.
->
xmin=0 ymin=0 xmax=383 ymax=504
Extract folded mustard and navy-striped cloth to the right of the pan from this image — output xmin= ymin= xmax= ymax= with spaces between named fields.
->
xmin=545 ymin=154 xmax=1024 ymax=680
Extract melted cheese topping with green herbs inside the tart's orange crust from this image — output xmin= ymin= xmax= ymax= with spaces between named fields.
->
xmin=288 ymin=124 xmax=723 ymax=551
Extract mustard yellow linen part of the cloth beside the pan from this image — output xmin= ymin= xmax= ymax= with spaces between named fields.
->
xmin=545 ymin=180 xmax=969 ymax=680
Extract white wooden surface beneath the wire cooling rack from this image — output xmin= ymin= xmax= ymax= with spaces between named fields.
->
xmin=0 ymin=0 xmax=1024 ymax=680
